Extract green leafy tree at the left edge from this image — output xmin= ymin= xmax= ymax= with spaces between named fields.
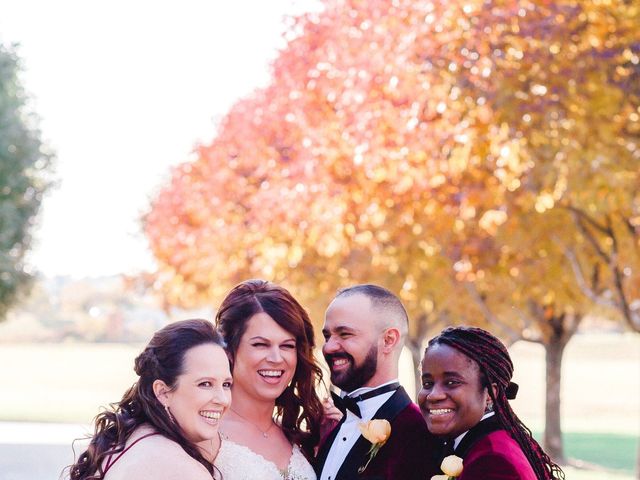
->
xmin=0 ymin=43 xmax=52 ymax=320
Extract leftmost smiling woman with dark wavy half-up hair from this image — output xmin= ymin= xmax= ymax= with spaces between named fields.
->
xmin=70 ymin=320 xmax=232 ymax=480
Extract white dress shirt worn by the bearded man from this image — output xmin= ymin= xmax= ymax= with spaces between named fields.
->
xmin=319 ymin=379 xmax=398 ymax=480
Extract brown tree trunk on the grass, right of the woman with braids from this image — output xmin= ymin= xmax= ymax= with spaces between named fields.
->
xmin=544 ymin=338 xmax=566 ymax=463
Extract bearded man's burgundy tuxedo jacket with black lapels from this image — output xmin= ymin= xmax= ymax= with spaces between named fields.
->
xmin=315 ymin=387 xmax=440 ymax=480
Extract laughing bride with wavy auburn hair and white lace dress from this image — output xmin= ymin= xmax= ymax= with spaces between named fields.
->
xmin=215 ymin=280 xmax=322 ymax=480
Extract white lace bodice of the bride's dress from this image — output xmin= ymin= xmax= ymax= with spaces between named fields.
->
xmin=215 ymin=437 xmax=316 ymax=480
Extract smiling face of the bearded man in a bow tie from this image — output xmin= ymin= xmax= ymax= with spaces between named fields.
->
xmin=322 ymin=294 xmax=381 ymax=392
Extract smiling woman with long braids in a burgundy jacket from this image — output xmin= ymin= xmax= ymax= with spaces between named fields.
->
xmin=418 ymin=327 xmax=564 ymax=480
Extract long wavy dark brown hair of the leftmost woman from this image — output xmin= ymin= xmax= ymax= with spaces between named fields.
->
xmin=69 ymin=320 xmax=224 ymax=480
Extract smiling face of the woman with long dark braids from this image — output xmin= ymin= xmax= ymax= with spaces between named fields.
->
xmin=418 ymin=344 xmax=490 ymax=438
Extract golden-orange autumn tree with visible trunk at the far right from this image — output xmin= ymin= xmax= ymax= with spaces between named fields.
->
xmin=404 ymin=2 xmax=640 ymax=459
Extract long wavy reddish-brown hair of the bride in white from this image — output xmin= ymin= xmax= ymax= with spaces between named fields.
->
xmin=216 ymin=280 xmax=322 ymax=458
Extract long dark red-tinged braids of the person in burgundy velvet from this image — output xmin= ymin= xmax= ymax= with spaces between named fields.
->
xmin=427 ymin=327 xmax=565 ymax=480
